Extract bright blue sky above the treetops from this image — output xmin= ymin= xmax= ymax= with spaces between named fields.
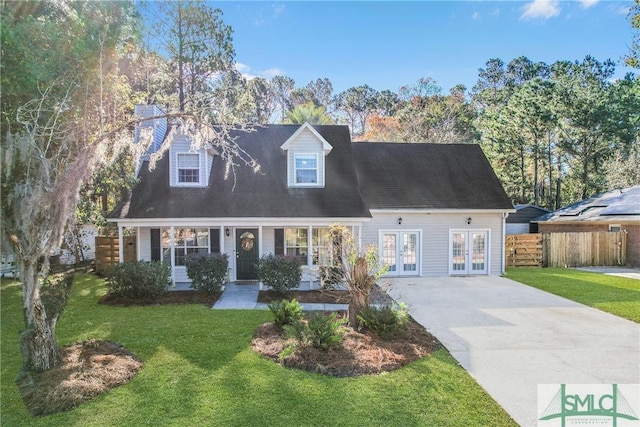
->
xmin=212 ymin=0 xmax=637 ymax=93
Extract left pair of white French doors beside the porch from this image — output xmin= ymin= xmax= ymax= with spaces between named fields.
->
xmin=380 ymin=231 xmax=420 ymax=276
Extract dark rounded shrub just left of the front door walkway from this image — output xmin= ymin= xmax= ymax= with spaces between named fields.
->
xmin=185 ymin=254 xmax=229 ymax=293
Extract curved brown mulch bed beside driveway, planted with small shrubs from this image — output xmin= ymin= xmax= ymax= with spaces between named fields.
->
xmin=251 ymin=319 xmax=443 ymax=377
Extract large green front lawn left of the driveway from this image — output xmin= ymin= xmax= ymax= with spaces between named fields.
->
xmin=0 ymin=275 xmax=516 ymax=427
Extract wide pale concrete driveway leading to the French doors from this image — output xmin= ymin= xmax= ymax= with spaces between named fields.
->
xmin=389 ymin=276 xmax=640 ymax=427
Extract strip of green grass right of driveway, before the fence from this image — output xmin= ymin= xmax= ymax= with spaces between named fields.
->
xmin=505 ymin=268 xmax=640 ymax=323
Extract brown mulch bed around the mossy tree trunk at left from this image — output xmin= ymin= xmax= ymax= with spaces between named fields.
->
xmin=17 ymin=340 xmax=142 ymax=416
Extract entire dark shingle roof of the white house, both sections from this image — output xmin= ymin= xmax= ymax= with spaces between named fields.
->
xmin=110 ymin=125 xmax=513 ymax=219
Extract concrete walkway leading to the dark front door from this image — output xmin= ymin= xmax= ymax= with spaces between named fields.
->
xmin=212 ymin=282 xmax=348 ymax=311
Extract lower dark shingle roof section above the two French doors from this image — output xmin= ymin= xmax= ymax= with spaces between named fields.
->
xmin=353 ymin=142 xmax=513 ymax=209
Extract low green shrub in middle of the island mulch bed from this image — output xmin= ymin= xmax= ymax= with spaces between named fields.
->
xmin=284 ymin=311 xmax=347 ymax=350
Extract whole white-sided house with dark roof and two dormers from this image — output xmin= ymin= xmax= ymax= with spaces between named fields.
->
xmin=110 ymin=108 xmax=513 ymax=282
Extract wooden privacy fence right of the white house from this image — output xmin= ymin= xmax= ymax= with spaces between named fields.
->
xmin=505 ymin=231 xmax=627 ymax=267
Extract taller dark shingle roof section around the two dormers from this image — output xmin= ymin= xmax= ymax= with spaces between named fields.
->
xmin=114 ymin=125 xmax=371 ymax=218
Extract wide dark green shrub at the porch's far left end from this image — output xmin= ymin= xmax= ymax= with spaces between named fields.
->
xmin=107 ymin=261 xmax=171 ymax=300
